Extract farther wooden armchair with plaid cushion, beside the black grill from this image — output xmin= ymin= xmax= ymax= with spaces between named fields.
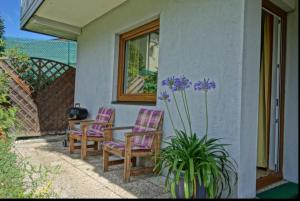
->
xmin=69 ymin=107 xmax=115 ymax=159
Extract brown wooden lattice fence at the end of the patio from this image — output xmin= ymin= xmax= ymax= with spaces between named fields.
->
xmin=0 ymin=58 xmax=75 ymax=136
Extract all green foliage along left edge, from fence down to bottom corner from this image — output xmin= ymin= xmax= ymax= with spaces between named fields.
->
xmin=0 ymin=73 xmax=58 ymax=198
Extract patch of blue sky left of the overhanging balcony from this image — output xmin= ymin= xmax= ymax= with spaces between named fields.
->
xmin=0 ymin=0 xmax=54 ymax=40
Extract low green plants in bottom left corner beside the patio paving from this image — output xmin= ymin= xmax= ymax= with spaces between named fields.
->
xmin=0 ymin=139 xmax=59 ymax=198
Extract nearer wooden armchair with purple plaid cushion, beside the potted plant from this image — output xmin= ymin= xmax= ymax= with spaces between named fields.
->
xmin=103 ymin=108 xmax=163 ymax=182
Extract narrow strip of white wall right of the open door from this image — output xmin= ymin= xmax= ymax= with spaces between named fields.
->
xmin=283 ymin=1 xmax=299 ymax=183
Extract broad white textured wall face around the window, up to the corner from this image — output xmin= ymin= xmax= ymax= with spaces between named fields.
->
xmin=75 ymin=0 xmax=247 ymax=173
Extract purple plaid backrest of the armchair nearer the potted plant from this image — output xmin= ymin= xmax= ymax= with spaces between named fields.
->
xmin=132 ymin=108 xmax=164 ymax=149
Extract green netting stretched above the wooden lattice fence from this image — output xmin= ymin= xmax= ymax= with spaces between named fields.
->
xmin=4 ymin=37 xmax=77 ymax=67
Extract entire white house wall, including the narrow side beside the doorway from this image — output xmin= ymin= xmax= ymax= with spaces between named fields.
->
xmin=75 ymin=0 xmax=261 ymax=197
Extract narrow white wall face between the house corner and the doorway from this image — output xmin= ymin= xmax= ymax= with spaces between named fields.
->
xmin=238 ymin=0 xmax=261 ymax=198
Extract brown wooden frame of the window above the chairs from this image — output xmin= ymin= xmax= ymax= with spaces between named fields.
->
xmin=117 ymin=19 xmax=160 ymax=103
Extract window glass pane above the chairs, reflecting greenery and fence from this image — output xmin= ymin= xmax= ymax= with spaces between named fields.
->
xmin=124 ymin=32 xmax=159 ymax=94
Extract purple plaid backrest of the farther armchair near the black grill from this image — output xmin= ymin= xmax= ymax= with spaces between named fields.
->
xmin=92 ymin=107 xmax=115 ymax=131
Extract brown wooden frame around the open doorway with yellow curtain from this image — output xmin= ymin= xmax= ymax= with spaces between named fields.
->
xmin=256 ymin=0 xmax=287 ymax=190
